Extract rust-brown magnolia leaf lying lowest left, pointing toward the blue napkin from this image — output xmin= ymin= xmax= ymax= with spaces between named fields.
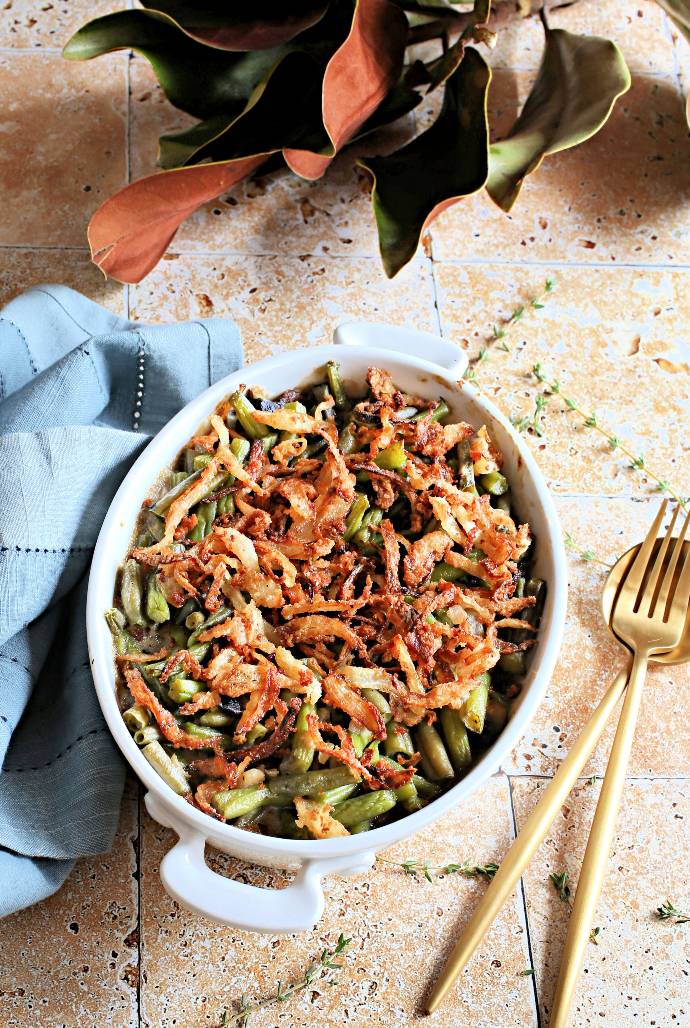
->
xmin=87 ymin=153 xmax=268 ymax=283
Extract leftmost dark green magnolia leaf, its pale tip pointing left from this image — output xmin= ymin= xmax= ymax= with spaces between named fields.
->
xmin=63 ymin=10 xmax=284 ymax=122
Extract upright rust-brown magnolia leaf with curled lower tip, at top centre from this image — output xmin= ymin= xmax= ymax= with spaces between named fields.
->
xmin=284 ymin=0 xmax=407 ymax=179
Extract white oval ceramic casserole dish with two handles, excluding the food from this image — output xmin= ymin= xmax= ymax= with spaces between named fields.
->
xmin=86 ymin=322 xmax=567 ymax=933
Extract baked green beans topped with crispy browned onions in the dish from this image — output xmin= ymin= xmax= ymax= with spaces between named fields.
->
xmin=106 ymin=362 xmax=545 ymax=839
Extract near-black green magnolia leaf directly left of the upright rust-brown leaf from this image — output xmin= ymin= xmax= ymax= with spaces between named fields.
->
xmin=159 ymin=51 xmax=323 ymax=167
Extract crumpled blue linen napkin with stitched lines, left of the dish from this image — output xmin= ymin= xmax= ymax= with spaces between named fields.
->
xmin=0 ymin=286 xmax=242 ymax=917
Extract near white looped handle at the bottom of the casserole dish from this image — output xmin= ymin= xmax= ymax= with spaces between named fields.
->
xmin=145 ymin=793 xmax=374 ymax=935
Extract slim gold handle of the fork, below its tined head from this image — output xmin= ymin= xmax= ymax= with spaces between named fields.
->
xmin=549 ymin=650 xmax=649 ymax=1028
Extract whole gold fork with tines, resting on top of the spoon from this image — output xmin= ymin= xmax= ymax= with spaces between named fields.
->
xmin=550 ymin=501 xmax=690 ymax=1028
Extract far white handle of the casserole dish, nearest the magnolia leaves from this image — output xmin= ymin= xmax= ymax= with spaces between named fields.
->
xmin=333 ymin=321 xmax=468 ymax=378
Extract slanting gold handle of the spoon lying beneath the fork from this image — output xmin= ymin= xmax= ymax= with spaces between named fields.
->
xmin=426 ymin=669 xmax=627 ymax=1014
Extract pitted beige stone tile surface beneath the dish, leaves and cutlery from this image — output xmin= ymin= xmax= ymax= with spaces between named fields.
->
xmin=0 ymin=0 xmax=690 ymax=1028
